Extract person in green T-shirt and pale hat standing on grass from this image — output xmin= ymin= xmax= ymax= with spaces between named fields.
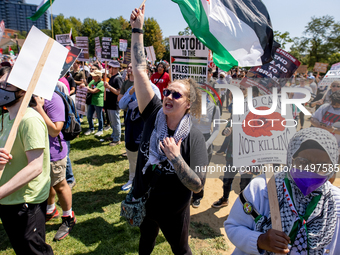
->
xmin=84 ymin=70 xmax=105 ymax=136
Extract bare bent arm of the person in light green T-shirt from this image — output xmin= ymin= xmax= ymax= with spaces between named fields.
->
xmin=0 ymin=149 xmax=44 ymax=199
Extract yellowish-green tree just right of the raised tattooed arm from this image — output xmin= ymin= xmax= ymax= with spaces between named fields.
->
xmin=144 ymin=18 xmax=165 ymax=60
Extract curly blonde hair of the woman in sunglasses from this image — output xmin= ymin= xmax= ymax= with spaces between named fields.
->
xmin=172 ymin=78 xmax=202 ymax=119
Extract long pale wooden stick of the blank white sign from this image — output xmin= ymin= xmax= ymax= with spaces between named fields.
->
xmin=0 ymin=38 xmax=54 ymax=178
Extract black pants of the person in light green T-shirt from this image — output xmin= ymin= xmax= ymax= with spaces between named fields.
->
xmin=0 ymin=200 xmax=53 ymax=255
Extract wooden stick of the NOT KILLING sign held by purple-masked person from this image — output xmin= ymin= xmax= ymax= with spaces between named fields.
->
xmin=265 ymin=164 xmax=282 ymax=254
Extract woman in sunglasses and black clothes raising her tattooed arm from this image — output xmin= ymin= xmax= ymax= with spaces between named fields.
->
xmin=130 ymin=6 xmax=208 ymax=254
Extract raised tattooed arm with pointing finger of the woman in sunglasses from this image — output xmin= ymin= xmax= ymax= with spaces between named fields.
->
xmin=130 ymin=5 xmax=155 ymax=113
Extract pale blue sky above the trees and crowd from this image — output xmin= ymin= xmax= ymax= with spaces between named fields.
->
xmin=26 ymin=0 xmax=340 ymax=47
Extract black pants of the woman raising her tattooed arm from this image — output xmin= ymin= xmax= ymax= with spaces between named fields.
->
xmin=139 ymin=204 xmax=192 ymax=255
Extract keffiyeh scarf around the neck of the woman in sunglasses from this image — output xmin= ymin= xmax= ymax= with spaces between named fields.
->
xmin=142 ymin=108 xmax=191 ymax=174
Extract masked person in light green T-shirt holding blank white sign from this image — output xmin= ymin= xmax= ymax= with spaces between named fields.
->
xmin=0 ymin=67 xmax=53 ymax=254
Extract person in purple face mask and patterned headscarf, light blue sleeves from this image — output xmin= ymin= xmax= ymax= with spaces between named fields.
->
xmin=224 ymin=128 xmax=340 ymax=255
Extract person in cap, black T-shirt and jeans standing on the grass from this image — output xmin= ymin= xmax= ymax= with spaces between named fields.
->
xmin=104 ymin=60 xmax=123 ymax=146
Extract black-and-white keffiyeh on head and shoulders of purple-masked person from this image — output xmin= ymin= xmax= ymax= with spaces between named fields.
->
xmin=256 ymin=128 xmax=338 ymax=255
